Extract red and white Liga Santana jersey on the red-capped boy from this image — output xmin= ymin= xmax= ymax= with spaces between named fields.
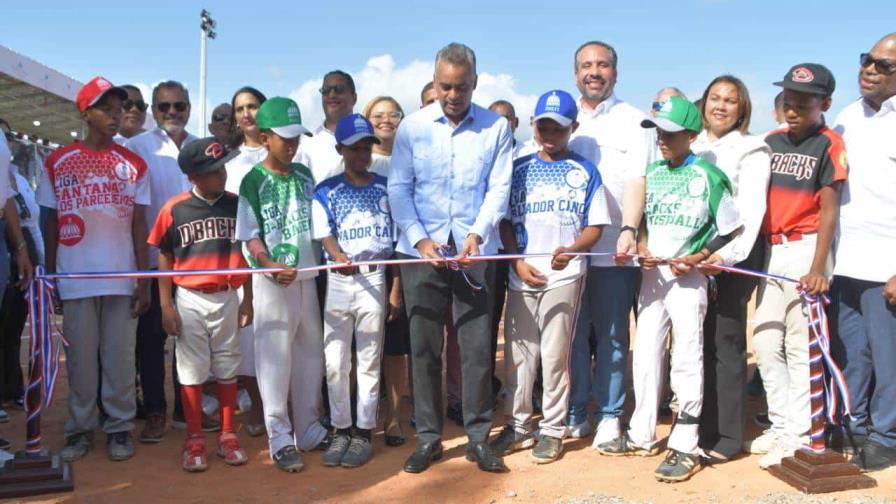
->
xmin=37 ymin=142 xmax=150 ymax=300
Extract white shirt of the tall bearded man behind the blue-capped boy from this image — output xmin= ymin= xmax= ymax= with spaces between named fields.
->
xmin=569 ymin=95 xmax=655 ymax=266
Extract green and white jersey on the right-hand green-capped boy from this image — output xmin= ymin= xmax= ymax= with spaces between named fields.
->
xmin=644 ymin=154 xmax=741 ymax=258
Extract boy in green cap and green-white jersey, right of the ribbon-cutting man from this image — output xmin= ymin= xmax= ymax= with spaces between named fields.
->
xmin=598 ymin=96 xmax=742 ymax=482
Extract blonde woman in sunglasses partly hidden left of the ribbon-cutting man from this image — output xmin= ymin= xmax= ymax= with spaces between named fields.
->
xmin=363 ymin=96 xmax=411 ymax=446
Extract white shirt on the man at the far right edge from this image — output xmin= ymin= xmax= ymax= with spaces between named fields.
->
xmin=834 ymin=96 xmax=896 ymax=282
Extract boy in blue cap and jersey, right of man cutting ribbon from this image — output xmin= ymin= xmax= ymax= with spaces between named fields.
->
xmin=492 ymin=90 xmax=610 ymax=464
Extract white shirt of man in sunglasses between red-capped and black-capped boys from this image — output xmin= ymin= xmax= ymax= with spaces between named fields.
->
xmin=125 ymin=126 xmax=197 ymax=268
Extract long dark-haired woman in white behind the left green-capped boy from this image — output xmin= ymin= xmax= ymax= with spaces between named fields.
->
xmin=225 ymin=86 xmax=268 ymax=437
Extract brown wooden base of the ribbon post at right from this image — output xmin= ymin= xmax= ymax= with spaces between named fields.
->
xmin=768 ymin=450 xmax=877 ymax=494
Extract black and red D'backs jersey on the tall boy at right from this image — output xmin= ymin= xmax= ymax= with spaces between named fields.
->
xmin=762 ymin=125 xmax=846 ymax=236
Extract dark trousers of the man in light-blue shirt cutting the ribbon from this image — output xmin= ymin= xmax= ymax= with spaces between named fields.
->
xmin=399 ymin=255 xmax=495 ymax=442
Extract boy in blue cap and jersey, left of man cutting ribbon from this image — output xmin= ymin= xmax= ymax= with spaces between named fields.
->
xmin=312 ymin=114 xmax=393 ymax=467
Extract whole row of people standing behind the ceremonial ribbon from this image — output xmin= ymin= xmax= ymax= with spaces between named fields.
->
xmin=0 ymin=34 xmax=896 ymax=482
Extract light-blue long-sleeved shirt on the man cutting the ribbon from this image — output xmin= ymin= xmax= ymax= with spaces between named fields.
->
xmin=389 ymin=103 xmax=513 ymax=257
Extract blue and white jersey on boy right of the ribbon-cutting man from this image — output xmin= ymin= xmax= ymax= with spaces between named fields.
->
xmin=506 ymin=153 xmax=610 ymax=291
